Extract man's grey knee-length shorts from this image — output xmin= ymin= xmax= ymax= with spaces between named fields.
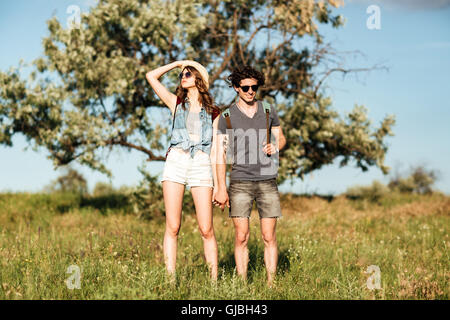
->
xmin=228 ymin=178 xmax=281 ymax=218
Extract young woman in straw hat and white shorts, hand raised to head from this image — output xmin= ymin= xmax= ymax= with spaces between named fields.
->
xmin=146 ymin=60 xmax=220 ymax=280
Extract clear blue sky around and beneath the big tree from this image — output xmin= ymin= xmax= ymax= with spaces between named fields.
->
xmin=0 ymin=0 xmax=450 ymax=194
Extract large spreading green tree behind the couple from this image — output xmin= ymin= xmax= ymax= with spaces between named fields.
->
xmin=0 ymin=0 xmax=394 ymax=184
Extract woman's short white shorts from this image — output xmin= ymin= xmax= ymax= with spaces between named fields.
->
xmin=161 ymin=148 xmax=214 ymax=188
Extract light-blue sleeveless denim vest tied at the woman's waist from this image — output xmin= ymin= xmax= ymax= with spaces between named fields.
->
xmin=169 ymin=100 xmax=213 ymax=158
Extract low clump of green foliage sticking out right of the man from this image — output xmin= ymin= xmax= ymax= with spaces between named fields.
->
xmin=279 ymin=96 xmax=395 ymax=180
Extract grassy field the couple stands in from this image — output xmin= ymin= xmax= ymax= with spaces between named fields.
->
xmin=0 ymin=190 xmax=450 ymax=299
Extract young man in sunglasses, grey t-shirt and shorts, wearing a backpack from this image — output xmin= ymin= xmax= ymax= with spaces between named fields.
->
xmin=214 ymin=66 xmax=286 ymax=286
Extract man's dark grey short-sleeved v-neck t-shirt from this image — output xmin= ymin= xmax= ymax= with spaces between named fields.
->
xmin=217 ymin=101 xmax=280 ymax=181
